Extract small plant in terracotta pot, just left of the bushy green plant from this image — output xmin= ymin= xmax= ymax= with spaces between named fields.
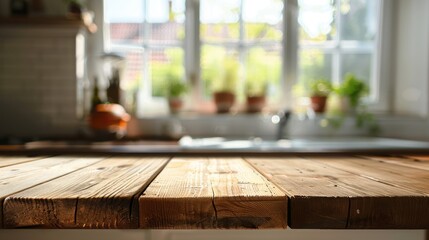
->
xmin=310 ymin=79 xmax=332 ymax=113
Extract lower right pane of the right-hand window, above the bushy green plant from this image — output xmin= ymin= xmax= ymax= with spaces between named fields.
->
xmin=341 ymin=54 xmax=372 ymax=84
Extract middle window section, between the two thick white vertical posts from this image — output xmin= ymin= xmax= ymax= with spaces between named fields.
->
xmin=200 ymin=0 xmax=283 ymax=107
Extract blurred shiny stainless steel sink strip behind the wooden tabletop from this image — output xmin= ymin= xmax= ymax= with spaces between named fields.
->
xmin=179 ymin=136 xmax=429 ymax=152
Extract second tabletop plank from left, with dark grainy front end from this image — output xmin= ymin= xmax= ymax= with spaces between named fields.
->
xmin=4 ymin=157 xmax=168 ymax=228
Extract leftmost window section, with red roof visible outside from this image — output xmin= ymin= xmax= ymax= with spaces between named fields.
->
xmin=105 ymin=0 xmax=185 ymax=115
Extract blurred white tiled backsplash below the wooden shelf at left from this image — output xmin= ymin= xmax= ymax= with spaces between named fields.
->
xmin=0 ymin=26 xmax=84 ymax=137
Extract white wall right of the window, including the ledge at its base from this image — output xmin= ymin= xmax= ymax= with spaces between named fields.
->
xmin=380 ymin=0 xmax=429 ymax=140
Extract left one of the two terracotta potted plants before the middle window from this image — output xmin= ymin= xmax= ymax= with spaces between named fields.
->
xmin=213 ymin=59 xmax=238 ymax=113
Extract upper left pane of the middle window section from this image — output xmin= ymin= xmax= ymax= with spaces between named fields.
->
xmin=200 ymin=0 xmax=240 ymax=41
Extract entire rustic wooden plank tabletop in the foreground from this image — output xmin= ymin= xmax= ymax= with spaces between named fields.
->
xmin=0 ymin=155 xmax=429 ymax=229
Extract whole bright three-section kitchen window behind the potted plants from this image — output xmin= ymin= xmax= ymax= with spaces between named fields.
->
xmin=104 ymin=0 xmax=382 ymax=115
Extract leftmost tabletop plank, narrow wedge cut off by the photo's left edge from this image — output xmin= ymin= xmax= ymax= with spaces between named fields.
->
xmin=0 ymin=156 xmax=101 ymax=228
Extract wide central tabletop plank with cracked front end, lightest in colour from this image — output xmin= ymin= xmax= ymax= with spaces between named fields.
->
xmin=140 ymin=158 xmax=287 ymax=229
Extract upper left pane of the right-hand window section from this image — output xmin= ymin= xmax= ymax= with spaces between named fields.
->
xmin=298 ymin=0 xmax=336 ymax=42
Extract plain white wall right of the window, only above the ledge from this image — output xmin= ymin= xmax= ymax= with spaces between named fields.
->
xmin=391 ymin=0 xmax=429 ymax=117
